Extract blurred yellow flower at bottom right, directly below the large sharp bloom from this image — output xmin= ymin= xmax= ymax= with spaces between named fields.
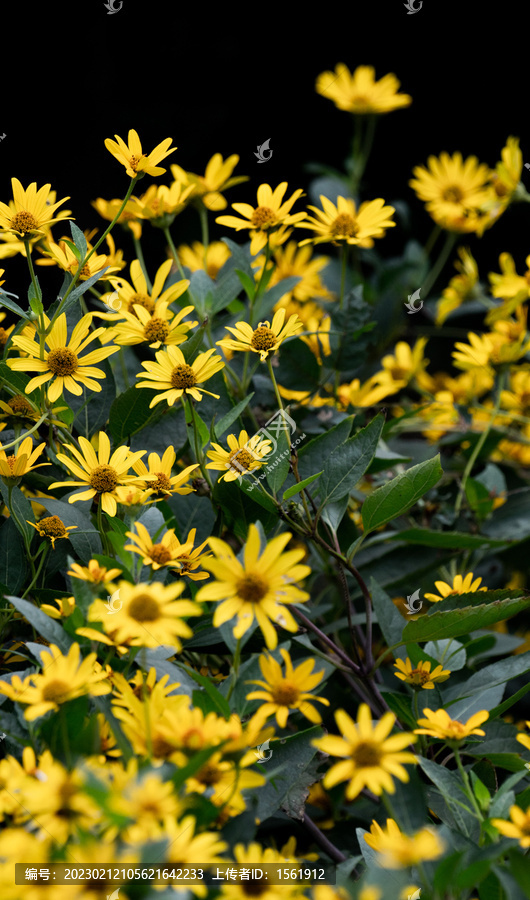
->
xmin=364 ymin=819 xmax=446 ymax=869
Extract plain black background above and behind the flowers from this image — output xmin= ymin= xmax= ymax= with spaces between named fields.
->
xmin=0 ymin=0 xmax=530 ymax=293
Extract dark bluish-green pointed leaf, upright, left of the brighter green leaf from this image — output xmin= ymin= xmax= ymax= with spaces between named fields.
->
xmin=319 ymin=414 xmax=385 ymax=505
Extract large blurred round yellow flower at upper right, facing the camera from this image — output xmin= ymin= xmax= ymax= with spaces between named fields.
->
xmin=409 ymin=152 xmax=491 ymax=232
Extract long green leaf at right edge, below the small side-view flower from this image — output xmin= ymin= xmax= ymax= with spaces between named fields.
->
xmin=402 ymin=591 xmax=530 ymax=643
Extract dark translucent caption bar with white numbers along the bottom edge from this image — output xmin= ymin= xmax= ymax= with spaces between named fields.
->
xmin=15 ymin=863 xmax=336 ymax=887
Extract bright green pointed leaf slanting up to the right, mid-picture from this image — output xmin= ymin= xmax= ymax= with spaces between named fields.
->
xmin=362 ymin=454 xmax=443 ymax=533
